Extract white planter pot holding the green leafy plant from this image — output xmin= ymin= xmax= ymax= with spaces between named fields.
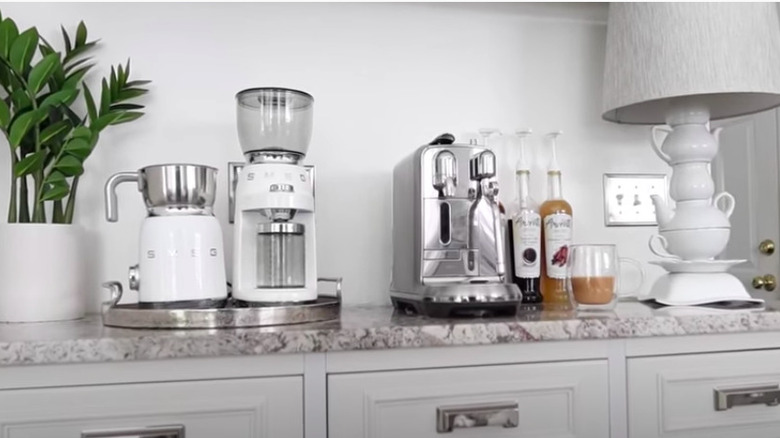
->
xmin=0 ymin=224 xmax=86 ymax=322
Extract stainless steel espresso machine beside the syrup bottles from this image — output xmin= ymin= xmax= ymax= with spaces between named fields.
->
xmin=390 ymin=134 xmax=521 ymax=317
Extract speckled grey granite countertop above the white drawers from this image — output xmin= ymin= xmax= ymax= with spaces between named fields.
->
xmin=0 ymin=302 xmax=780 ymax=366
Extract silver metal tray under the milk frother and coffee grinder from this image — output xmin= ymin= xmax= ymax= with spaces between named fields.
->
xmin=102 ymin=278 xmax=341 ymax=329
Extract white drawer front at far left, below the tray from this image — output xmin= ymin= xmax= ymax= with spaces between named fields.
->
xmin=0 ymin=377 xmax=303 ymax=438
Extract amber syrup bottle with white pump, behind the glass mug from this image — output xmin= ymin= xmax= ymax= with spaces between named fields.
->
xmin=539 ymin=131 xmax=573 ymax=304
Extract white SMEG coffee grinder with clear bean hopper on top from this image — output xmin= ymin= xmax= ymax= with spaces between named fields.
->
xmin=231 ymin=88 xmax=317 ymax=304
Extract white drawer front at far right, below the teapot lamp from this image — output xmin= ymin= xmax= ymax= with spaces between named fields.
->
xmin=628 ymin=350 xmax=780 ymax=438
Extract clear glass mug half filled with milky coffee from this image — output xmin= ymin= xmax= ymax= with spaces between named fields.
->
xmin=567 ymin=245 xmax=645 ymax=310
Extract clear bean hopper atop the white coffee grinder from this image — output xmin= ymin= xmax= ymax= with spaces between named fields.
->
xmin=236 ymin=88 xmax=314 ymax=155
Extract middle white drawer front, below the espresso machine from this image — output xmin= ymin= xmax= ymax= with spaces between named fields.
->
xmin=328 ymin=361 xmax=609 ymax=438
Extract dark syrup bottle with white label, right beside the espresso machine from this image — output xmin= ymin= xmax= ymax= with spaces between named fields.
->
xmin=511 ymin=129 xmax=542 ymax=304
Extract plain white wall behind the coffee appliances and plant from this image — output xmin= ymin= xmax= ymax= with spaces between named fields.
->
xmin=0 ymin=3 xmax=666 ymax=308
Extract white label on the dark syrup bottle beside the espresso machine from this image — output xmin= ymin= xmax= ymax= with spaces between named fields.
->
xmin=512 ymin=210 xmax=542 ymax=278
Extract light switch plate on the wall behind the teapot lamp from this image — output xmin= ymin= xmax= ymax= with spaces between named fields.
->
xmin=604 ymin=173 xmax=667 ymax=227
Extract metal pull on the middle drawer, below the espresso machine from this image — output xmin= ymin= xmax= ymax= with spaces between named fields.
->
xmin=436 ymin=402 xmax=520 ymax=433
